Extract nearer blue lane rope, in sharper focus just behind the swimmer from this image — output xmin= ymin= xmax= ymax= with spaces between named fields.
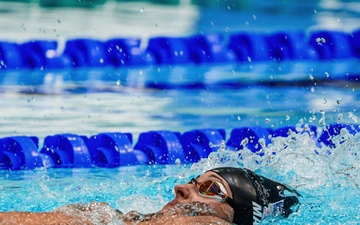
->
xmin=0 ymin=124 xmax=360 ymax=170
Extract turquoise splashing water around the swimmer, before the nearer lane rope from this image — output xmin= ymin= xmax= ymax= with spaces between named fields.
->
xmin=0 ymin=134 xmax=360 ymax=224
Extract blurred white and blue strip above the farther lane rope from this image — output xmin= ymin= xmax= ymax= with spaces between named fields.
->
xmin=0 ymin=0 xmax=360 ymax=41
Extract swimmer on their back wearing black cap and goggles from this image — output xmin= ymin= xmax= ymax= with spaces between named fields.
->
xmin=0 ymin=167 xmax=300 ymax=225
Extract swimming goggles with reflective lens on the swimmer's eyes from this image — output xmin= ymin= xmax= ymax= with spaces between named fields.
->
xmin=189 ymin=178 xmax=231 ymax=202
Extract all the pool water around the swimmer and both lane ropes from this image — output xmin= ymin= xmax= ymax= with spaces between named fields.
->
xmin=0 ymin=0 xmax=360 ymax=224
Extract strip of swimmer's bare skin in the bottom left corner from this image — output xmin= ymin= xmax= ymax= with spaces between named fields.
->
xmin=0 ymin=212 xmax=91 ymax=225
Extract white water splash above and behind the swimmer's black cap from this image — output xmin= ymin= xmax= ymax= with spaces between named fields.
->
xmin=190 ymin=129 xmax=360 ymax=224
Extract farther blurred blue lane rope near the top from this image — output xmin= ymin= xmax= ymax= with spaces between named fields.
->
xmin=0 ymin=30 xmax=360 ymax=70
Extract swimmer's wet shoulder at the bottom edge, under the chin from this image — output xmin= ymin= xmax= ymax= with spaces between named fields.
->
xmin=134 ymin=215 xmax=232 ymax=225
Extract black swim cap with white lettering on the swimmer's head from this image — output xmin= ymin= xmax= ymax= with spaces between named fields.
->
xmin=209 ymin=167 xmax=300 ymax=225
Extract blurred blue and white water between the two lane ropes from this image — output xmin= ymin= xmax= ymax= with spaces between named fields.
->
xmin=0 ymin=60 xmax=360 ymax=140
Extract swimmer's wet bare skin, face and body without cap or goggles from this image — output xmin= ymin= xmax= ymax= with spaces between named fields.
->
xmin=0 ymin=172 xmax=234 ymax=225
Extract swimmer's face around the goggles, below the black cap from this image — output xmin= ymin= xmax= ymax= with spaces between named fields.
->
xmin=161 ymin=171 xmax=234 ymax=223
